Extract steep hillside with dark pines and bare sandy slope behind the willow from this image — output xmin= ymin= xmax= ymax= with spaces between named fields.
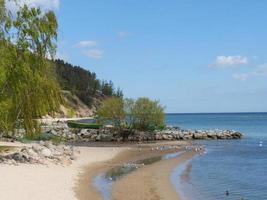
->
xmin=55 ymin=60 xmax=123 ymax=117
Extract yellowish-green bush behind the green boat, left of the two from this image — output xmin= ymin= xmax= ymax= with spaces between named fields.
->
xmin=97 ymin=97 xmax=125 ymax=127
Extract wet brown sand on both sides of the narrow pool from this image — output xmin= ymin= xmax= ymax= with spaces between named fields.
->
xmin=75 ymin=141 xmax=196 ymax=200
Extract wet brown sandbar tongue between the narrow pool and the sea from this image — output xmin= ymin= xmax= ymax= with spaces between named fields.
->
xmin=112 ymin=151 xmax=195 ymax=200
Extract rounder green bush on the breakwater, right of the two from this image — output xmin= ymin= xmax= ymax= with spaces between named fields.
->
xmin=131 ymin=97 xmax=165 ymax=130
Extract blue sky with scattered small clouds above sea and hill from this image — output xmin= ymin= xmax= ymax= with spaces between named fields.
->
xmin=7 ymin=0 xmax=267 ymax=113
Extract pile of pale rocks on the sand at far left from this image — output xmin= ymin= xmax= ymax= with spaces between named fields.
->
xmin=0 ymin=141 xmax=75 ymax=165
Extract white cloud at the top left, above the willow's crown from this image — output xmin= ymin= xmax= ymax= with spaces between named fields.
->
xmin=6 ymin=0 xmax=60 ymax=13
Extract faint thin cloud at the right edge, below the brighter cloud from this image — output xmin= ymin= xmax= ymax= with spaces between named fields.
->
xmin=233 ymin=63 xmax=267 ymax=81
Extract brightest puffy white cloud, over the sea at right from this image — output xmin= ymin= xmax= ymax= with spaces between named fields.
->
xmin=211 ymin=55 xmax=248 ymax=68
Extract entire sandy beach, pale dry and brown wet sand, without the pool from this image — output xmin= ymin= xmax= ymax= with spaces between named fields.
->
xmin=0 ymin=141 xmax=195 ymax=200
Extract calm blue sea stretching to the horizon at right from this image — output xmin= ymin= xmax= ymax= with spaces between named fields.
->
xmin=166 ymin=113 xmax=267 ymax=200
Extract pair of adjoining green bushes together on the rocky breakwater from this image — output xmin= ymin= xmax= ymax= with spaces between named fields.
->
xmin=97 ymin=97 xmax=165 ymax=131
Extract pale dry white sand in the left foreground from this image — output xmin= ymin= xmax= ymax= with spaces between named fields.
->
xmin=0 ymin=147 xmax=122 ymax=200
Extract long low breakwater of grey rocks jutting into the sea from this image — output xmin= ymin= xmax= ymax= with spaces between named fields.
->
xmin=47 ymin=122 xmax=243 ymax=142
